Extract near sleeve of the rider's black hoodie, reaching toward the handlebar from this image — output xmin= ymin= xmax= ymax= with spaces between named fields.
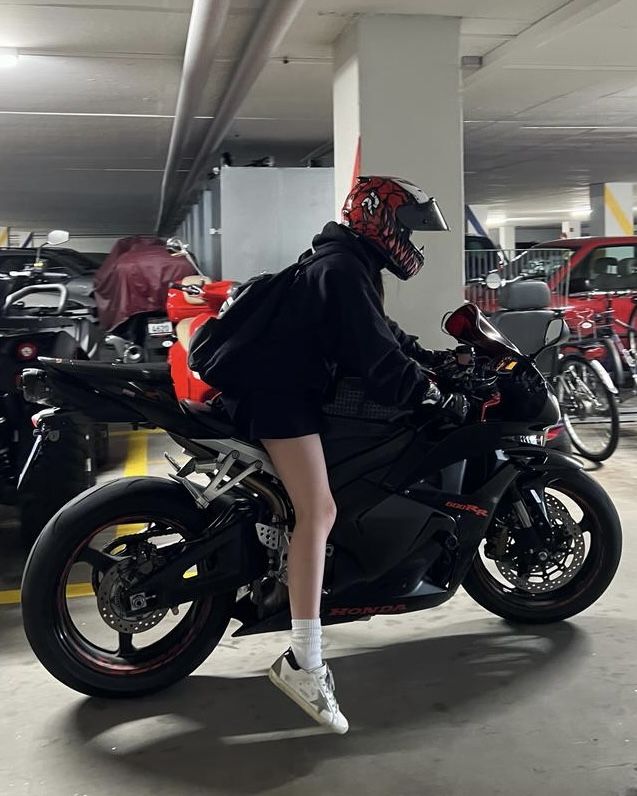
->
xmin=321 ymin=262 xmax=430 ymax=406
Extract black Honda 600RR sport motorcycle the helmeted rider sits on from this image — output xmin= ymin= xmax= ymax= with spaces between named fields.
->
xmin=22 ymin=304 xmax=621 ymax=697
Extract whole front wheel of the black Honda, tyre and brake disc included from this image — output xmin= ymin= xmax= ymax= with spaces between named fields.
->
xmin=463 ymin=470 xmax=622 ymax=624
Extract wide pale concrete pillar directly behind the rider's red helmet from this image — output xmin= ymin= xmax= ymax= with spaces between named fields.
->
xmin=333 ymin=15 xmax=464 ymax=346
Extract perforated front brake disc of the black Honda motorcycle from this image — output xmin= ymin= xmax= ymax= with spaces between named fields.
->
xmin=495 ymin=494 xmax=586 ymax=594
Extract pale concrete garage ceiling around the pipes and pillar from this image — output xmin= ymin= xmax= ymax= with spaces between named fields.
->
xmin=0 ymin=0 xmax=637 ymax=234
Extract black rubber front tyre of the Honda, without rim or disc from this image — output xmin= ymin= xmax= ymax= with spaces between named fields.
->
xmin=463 ymin=470 xmax=622 ymax=624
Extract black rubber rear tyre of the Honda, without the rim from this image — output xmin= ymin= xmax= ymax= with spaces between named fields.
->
xmin=22 ymin=477 xmax=235 ymax=697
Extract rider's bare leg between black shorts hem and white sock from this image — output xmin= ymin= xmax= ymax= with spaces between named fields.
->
xmin=262 ymin=434 xmax=336 ymax=619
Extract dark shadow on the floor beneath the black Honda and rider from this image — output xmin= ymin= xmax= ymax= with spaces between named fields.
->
xmin=64 ymin=620 xmax=588 ymax=794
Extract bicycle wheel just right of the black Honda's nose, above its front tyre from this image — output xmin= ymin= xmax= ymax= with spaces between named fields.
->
xmin=556 ymin=354 xmax=619 ymax=462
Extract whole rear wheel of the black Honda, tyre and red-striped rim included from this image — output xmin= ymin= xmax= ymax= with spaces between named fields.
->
xmin=22 ymin=478 xmax=235 ymax=697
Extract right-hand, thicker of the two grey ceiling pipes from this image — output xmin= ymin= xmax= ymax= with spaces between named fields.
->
xmin=162 ymin=0 xmax=303 ymax=232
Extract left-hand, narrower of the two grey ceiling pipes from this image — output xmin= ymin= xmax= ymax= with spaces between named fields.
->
xmin=156 ymin=0 xmax=230 ymax=231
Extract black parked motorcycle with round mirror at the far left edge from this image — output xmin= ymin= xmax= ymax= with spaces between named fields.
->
xmin=0 ymin=230 xmax=98 ymax=546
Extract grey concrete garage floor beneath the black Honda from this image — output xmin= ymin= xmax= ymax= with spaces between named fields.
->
xmin=0 ymin=430 xmax=637 ymax=796
